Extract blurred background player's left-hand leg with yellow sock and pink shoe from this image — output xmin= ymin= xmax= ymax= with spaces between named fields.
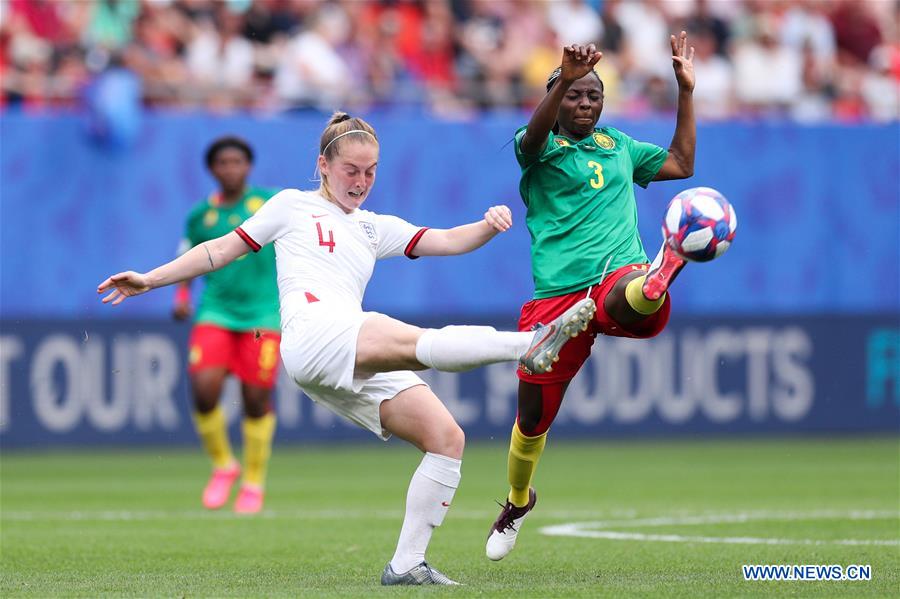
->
xmin=191 ymin=366 xmax=241 ymax=510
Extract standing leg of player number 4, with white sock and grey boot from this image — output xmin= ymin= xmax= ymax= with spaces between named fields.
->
xmin=380 ymin=385 xmax=465 ymax=585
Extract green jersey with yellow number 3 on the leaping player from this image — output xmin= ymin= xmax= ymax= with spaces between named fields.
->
xmin=515 ymin=127 xmax=668 ymax=299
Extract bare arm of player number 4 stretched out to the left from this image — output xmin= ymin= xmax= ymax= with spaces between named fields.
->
xmin=97 ymin=231 xmax=250 ymax=306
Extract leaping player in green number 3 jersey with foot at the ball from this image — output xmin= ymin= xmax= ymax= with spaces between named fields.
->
xmin=486 ymin=31 xmax=697 ymax=560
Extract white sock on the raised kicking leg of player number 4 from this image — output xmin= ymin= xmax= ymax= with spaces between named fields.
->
xmin=416 ymin=326 xmax=534 ymax=372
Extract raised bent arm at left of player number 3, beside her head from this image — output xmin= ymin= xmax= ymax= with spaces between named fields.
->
xmin=519 ymin=44 xmax=603 ymax=156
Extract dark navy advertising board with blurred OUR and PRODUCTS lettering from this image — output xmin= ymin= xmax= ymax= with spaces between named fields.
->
xmin=0 ymin=315 xmax=900 ymax=449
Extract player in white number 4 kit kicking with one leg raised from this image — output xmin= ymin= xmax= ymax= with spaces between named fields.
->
xmin=97 ymin=112 xmax=595 ymax=585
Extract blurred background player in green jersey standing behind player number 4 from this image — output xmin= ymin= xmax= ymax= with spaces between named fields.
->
xmin=173 ymin=137 xmax=281 ymax=513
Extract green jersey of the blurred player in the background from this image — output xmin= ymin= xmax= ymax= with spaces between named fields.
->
xmin=183 ymin=187 xmax=281 ymax=331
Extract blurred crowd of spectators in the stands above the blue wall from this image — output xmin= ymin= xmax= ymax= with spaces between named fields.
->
xmin=0 ymin=0 xmax=900 ymax=122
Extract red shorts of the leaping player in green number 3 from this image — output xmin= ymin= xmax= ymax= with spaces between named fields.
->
xmin=517 ymin=264 xmax=671 ymax=385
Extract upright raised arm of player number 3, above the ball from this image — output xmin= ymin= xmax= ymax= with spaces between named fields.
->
xmin=653 ymin=31 xmax=697 ymax=181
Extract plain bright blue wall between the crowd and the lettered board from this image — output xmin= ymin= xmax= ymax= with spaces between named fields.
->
xmin=0 ymin=111 xmax=900 ymax=319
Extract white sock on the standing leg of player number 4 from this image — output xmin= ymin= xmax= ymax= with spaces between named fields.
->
xmin=391 ymin=453 xmax=462 ymax=574
